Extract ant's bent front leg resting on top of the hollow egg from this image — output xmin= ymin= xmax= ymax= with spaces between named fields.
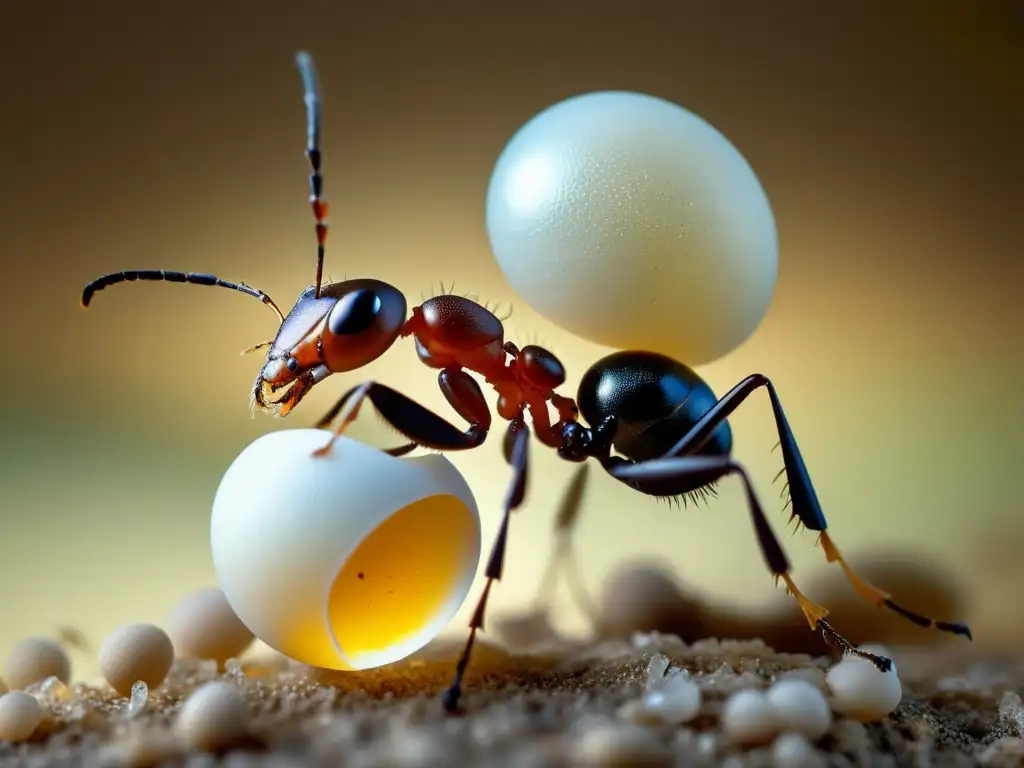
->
xmin=314 ymin=368 xmax=490 ymax=456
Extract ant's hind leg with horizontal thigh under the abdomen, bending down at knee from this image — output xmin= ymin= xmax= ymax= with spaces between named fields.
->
xmin=603 ymin=456 xmax=892 ymax=672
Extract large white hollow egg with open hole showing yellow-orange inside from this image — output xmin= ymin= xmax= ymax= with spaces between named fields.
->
xmin=210 ymin=429 xmax=480 ymax=670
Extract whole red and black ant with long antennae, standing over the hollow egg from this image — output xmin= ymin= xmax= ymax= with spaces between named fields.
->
xmin=81 ymin=52 xmax=971 ymax=712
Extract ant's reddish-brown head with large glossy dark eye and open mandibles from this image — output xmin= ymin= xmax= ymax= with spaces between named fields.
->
xmin=253 ymin=278 xmax=407 ymax=416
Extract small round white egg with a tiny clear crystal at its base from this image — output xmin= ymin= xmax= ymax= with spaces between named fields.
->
xmin=99 ymin=623 xmax=174 ymax=696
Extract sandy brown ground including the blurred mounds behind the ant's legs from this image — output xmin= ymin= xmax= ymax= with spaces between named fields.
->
xmin=0 ymin=560 xmax=1024 ymax=768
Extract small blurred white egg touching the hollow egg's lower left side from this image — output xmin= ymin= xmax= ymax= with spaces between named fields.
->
xmin=167 ymin=587 xmax=254 ymax=664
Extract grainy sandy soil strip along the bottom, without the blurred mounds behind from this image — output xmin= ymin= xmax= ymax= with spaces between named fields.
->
xmin=0 ymin=633 xmax=1024 ymax=768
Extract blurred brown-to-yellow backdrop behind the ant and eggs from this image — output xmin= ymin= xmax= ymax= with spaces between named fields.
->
xmin=0 ymin=0 xmax=1024 ymax=675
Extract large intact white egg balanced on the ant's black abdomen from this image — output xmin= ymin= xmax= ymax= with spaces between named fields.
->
xmin=486 ymin=91 xmax=778 ymax=365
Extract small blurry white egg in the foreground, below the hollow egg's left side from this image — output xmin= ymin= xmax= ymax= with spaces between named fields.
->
xmin=175 ymin=681 xmax=249 ymax=752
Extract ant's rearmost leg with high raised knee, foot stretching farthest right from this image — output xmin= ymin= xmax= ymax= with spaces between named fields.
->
xmin=651 ymin=374 xmax=971 ymax=639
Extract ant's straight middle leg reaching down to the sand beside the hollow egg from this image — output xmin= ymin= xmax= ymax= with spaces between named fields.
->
xmin=441 ymin=416 xmax=529 ymax=712
